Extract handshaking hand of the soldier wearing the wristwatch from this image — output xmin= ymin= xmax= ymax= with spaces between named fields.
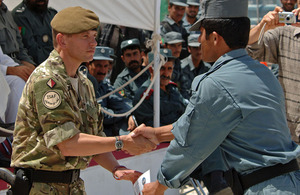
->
xmin=121 ymin=135 xmax=156 ymax=155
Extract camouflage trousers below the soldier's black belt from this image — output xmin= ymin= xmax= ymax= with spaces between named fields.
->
xmin=29 ymin=179 xmax=86 ymax=195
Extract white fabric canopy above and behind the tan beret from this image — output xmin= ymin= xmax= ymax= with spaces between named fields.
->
xmin=4 ymin=0 xmax=156 ymax=30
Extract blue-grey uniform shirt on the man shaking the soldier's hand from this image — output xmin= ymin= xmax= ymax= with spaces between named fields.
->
xmin=158 ymin=49 xmax=300 ymax=188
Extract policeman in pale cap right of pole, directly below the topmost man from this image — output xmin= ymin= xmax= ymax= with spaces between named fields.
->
xmin=164 ymin=31 xmax=184 ymax=83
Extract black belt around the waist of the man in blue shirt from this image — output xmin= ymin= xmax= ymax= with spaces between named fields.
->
xmin=224 ymin=159 xmax=299 ymax=195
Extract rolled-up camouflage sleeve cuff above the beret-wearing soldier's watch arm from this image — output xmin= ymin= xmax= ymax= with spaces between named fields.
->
xmin=44 ymin=122 xmax=80 ymax=148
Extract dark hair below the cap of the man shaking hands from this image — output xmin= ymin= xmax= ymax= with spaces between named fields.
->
xmin=201 ymin=17 xmax=250 ymax=49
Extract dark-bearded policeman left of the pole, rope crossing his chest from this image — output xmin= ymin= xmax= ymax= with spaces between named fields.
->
xmin=114 ymin=39 xmax=150 ymax=104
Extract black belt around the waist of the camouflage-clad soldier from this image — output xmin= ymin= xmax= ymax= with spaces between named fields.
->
xmin=17 ymin=168 xmax=80 ymax=184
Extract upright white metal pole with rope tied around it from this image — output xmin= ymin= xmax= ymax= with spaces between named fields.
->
xmin=153 ymin=0 xmax=161 ymax=127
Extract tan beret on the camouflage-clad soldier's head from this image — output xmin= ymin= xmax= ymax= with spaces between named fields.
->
xmin=51 ymin=6 xmax=100 ymax=34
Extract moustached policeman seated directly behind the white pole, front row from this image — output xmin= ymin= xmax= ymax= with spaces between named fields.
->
xmin=133 ymin=49 xmax=187 ymax=126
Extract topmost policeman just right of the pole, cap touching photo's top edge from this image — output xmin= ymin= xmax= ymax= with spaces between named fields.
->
xmin=160 ymin=0 xmax=189 ymax=59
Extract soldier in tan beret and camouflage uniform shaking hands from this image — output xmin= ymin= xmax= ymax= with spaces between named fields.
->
xmin=11 ymin=7 xmax=155 ymax=194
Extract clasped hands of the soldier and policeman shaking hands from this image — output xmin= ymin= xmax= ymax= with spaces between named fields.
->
xmin=120 ymin=124 xmax=174 ymax=155
